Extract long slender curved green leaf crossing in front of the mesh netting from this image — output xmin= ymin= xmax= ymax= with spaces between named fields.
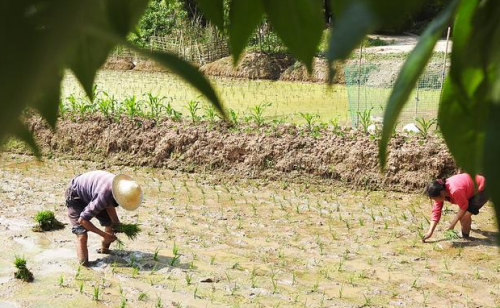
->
xmin=379 ymin=0 xmax=460 ymax=168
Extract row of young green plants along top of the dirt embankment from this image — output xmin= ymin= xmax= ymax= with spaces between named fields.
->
xmin=59 ymin=87 xmax=438 ymax=139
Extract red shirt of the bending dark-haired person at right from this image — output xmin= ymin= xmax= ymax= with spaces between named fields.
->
xmin=431 ymin=173 xmax=485 ymax=221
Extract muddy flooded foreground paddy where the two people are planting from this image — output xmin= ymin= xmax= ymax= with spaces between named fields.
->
xmin=0 ymin=154 xmax=500 ymax=308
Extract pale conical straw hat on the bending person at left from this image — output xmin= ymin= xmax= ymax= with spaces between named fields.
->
xmin=111 ymin=174 xmax=142 ymax=211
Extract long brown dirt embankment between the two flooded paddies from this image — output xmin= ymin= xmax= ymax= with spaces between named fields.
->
xmin=18 ymin=116 xmax=456 ymax=191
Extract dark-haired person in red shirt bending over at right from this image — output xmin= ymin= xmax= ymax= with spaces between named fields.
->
xmin=422 ymin=173 xmax=488 ymax=242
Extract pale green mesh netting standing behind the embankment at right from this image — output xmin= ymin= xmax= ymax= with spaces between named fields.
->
xmin=344 ymin=51 xmax=448 ymax=128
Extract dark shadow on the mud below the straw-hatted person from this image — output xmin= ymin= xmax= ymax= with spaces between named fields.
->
xmin=90 ymin=250 xmax=195 ymax=271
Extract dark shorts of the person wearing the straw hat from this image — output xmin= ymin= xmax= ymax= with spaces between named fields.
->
xmin=66 ymin=186 xmax=111 ymax=235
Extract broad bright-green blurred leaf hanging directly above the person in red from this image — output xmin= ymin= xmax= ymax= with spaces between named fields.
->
xmin=438 ymin=0 xmax=487 ymax=174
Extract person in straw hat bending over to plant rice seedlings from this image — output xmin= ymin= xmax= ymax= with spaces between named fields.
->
xmin=66 ymin=171 xmax=142 ymax=266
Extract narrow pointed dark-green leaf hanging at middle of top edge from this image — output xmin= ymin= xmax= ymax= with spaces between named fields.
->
xmin=229 ymin=0 xmax=264 ymax=64
